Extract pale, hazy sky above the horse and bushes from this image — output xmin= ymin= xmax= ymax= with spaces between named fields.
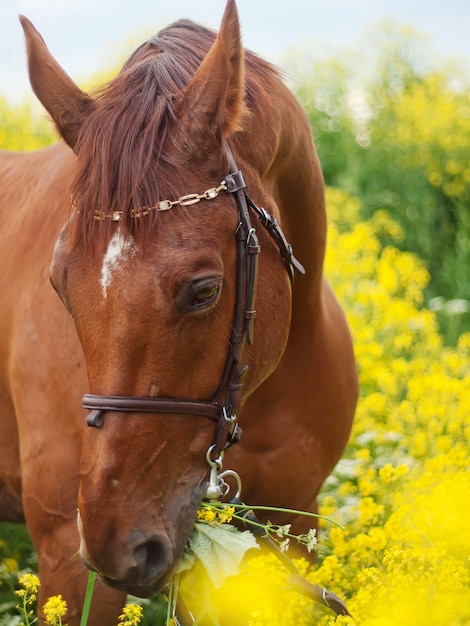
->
xmin=0 ymin=0 xmax=470 ymax=100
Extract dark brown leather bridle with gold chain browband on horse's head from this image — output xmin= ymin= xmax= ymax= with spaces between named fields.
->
xmin=83 ymin=145 xmax=305 ymax=459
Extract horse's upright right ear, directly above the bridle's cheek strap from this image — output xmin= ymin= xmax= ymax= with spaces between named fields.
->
xmin=180 ymin=0 xmax=246 ymax=141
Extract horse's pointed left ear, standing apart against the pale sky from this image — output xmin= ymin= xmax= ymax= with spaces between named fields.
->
xmin=20 ymin=15 xmax=94 ymax=149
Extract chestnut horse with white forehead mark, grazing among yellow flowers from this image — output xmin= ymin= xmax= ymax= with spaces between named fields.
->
xmin=0 ymin=0 xmax=357 ymax=626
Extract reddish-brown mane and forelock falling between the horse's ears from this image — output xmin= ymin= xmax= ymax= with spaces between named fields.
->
xmin=72 ymin=20 xmax=277 ymax=242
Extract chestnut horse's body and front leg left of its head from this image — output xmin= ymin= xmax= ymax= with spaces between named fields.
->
xmin=0 ymin=144 xmax=129 ymax=624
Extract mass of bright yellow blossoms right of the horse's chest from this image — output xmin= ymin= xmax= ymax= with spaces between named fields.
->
xmin=308 ymin=190 xmax=470 ymax=626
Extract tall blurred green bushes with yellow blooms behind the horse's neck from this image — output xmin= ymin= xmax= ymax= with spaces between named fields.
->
xmin=293 ymin=20 xmax=470 ymax=343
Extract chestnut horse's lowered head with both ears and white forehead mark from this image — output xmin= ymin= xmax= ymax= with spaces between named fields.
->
xmin=22 ymin=0 xmax=291 ymax=597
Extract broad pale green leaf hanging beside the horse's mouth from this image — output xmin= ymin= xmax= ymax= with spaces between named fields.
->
xmin=189 ymin=522 xmax=259 ymax=587
